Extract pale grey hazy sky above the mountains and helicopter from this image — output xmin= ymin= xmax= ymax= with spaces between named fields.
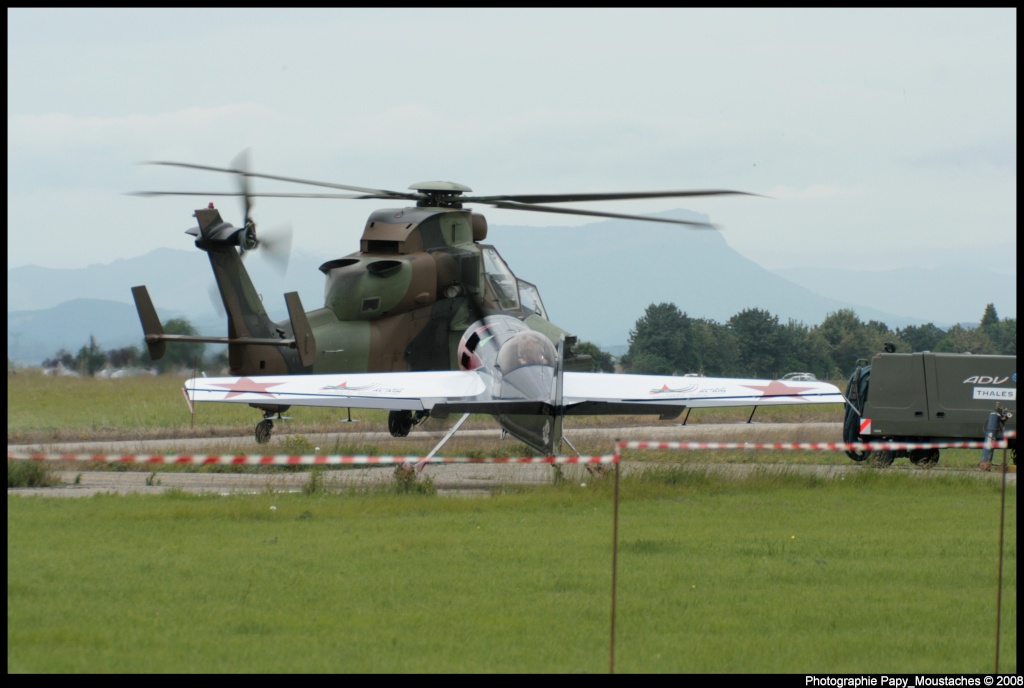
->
xmin=7 ymin=8 xmax=1017 ymax=276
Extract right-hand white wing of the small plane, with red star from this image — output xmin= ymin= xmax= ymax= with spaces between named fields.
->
xmin=563 ymin=373 xmax=846 ymax=415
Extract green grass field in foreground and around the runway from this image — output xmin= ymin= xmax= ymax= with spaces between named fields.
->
xmin=7 ymin=373 xmax=1017 ymax=674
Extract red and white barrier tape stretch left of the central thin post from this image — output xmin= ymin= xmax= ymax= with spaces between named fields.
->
xmin=7 ymin=452 xmax=618 ymax=466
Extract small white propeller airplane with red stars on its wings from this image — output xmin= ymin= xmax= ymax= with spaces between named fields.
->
xmin=184 ymin=315 xmax=846 ymax=457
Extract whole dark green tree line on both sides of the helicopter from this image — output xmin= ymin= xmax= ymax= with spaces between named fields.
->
xmin=32 ymin=303 xmax=1017 ymax=380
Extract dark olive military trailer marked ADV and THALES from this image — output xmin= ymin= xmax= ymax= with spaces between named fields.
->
xmin=843 ymin=345 xmax=1017 ymax=466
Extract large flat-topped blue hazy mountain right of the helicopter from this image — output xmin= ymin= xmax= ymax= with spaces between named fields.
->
xmin=487 ymin=211 xmax=942 ymax=349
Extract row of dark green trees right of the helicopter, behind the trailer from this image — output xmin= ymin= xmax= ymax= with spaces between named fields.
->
xmin=620 ymin=303 xmax=1017 ymax=380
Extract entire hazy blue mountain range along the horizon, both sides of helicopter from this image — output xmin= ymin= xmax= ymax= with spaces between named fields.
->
xmin=7 ymin=211 xmax=1017 ymax=364
